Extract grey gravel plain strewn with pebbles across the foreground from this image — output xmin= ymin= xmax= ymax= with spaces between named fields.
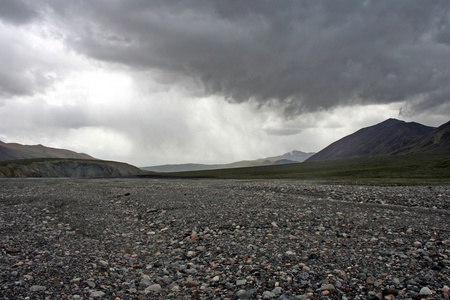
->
xmin=0 ymin=179 xmax=450 ymax=299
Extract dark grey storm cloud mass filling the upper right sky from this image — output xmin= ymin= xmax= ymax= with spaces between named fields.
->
xmin=5 ymin=0 xmax=450 ymax=115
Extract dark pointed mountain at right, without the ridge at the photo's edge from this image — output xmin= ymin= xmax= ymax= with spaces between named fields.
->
xmin=306 ymin=119 xmax=435 ymax=162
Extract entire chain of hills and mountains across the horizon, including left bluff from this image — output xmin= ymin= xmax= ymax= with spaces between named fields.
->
xmin=0 ymin=119 xmax=450 ymax=177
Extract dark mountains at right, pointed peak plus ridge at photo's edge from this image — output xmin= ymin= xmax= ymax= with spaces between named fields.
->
xmin=306 ymin=119 xmax=450 ymax=162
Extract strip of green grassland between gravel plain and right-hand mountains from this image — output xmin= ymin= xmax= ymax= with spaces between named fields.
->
xmin=144 ymin=153 xmax=450 ymax=184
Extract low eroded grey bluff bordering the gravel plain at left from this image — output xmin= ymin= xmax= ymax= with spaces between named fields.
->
xmin=0 ymin=159 xmax=142 ymax=178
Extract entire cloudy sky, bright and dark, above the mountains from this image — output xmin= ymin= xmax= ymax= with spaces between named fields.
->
xmin=0 ymin=0 xmax=450 ymax=167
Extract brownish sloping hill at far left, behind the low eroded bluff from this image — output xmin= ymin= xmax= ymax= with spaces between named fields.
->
xmin=0 ymin=141 xmax=95 ymax=161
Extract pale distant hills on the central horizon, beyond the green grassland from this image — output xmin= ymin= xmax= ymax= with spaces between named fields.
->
xmin=141 ymin=150 xmax=314 ymax=172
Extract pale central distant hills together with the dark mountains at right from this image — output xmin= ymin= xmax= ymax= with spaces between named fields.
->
xmin=147 ymin=119 xmax=450 ymax=172
